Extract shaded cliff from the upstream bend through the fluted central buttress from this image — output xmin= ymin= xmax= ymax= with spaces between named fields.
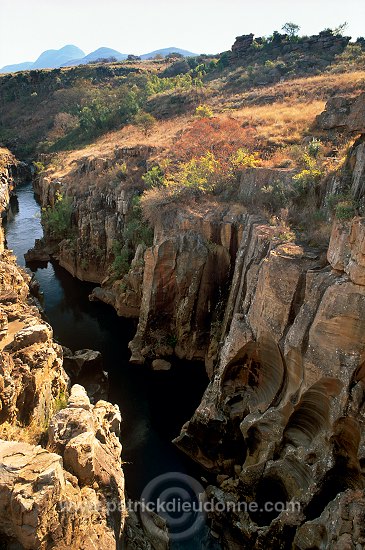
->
xmin=29 ymin=148 xmax=245 ymax=363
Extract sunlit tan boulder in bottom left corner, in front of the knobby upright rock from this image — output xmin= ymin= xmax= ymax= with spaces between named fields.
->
xmin=0 ymin=440 xmax=124 ymax=550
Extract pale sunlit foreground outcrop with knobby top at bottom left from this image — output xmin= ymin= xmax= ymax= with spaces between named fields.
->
xmin=0 ymin=386 xmax=126 ymax=550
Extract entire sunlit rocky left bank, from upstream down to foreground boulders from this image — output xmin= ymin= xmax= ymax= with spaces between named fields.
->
xmin=0 ymin=152 xmax=126 ymax=550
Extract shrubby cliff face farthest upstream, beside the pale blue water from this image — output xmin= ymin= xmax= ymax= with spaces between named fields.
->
xmin=34 ymin=147 xmax=152 ymax=292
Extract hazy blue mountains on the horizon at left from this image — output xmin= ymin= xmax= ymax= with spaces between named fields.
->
xmin=0 ymin=44 xmax=197 ymax=73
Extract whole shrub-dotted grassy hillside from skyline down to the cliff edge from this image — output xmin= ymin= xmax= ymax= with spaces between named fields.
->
xmin=0 ymin=31 xmax=365 ymax=258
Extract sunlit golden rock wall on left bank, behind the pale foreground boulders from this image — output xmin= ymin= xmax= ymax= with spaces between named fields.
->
xmin=0 ymin=153 xmax=68 ymax=434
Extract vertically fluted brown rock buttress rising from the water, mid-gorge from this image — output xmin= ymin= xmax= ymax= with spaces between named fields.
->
xmin=130 ymin=205 xmax=247 ymax=363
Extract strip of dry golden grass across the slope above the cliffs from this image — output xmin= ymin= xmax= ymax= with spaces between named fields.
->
xmin=47 ymin=101 xmax=318 ymax=178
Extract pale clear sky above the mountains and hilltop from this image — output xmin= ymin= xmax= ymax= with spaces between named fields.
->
xmin=0 ymin=0 xmax=365 ymax=67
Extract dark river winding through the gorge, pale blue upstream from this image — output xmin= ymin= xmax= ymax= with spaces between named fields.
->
xmin=6 ymin=183 xmax=213 ymax=549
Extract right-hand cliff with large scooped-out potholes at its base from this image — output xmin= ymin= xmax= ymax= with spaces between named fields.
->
xmin=170 ymin=102 xmax=365 ymax=550
